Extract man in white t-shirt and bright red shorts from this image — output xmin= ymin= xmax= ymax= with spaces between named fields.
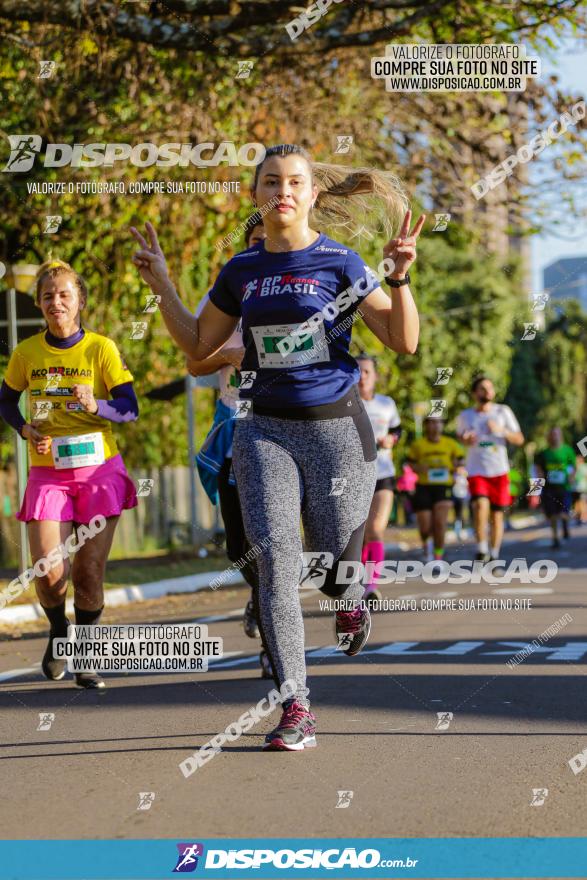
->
xmin=457 ymin=376 xmax=524 ymax=562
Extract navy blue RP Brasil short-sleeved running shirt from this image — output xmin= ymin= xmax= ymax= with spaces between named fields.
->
xmin=210 ymin=234 xmax=379 ymax=408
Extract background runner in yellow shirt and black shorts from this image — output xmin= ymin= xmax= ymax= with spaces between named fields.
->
xmin=408 ymin=418 xmax=464 ymax=562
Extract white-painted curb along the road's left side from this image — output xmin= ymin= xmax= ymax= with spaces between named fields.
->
xmin=0 ymin=571 xmax=243 ymax=626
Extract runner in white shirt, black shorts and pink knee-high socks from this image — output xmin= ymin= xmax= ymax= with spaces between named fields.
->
xmin=357 ymin=354 xmax=401 ymax=602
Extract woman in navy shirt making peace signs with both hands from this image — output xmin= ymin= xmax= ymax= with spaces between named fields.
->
xmin=132 ymin=144 xmax=425 ymax=750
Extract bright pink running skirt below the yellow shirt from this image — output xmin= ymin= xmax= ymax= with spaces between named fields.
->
xmin=16 ymin=455 xmax=137 ymax=525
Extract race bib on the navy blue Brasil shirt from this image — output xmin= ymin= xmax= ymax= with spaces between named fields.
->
xmin=251 ymin=323 xmax=330 ymax=369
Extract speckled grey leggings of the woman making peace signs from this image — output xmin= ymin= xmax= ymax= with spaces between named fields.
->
xmin=233 ymin=410 xmax=376 ymax=703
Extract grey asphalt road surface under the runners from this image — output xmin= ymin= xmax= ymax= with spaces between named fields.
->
xmin=0 ymin=527 xmax=587 ymax=852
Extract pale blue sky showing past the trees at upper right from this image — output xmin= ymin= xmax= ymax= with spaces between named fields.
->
xmin=528 ymin=39 xmax=587 ymax=293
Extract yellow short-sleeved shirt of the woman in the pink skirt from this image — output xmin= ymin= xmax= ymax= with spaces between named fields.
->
xmin=4 ymin=330 xmax=133 ymax=467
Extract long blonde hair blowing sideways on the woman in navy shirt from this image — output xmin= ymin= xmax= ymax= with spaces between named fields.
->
xmin=253 ymin=144 xmax=409 ymax=237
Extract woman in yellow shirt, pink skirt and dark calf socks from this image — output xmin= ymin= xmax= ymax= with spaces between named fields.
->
xmin=0 ymin=260 xmax=138 ymax=688
